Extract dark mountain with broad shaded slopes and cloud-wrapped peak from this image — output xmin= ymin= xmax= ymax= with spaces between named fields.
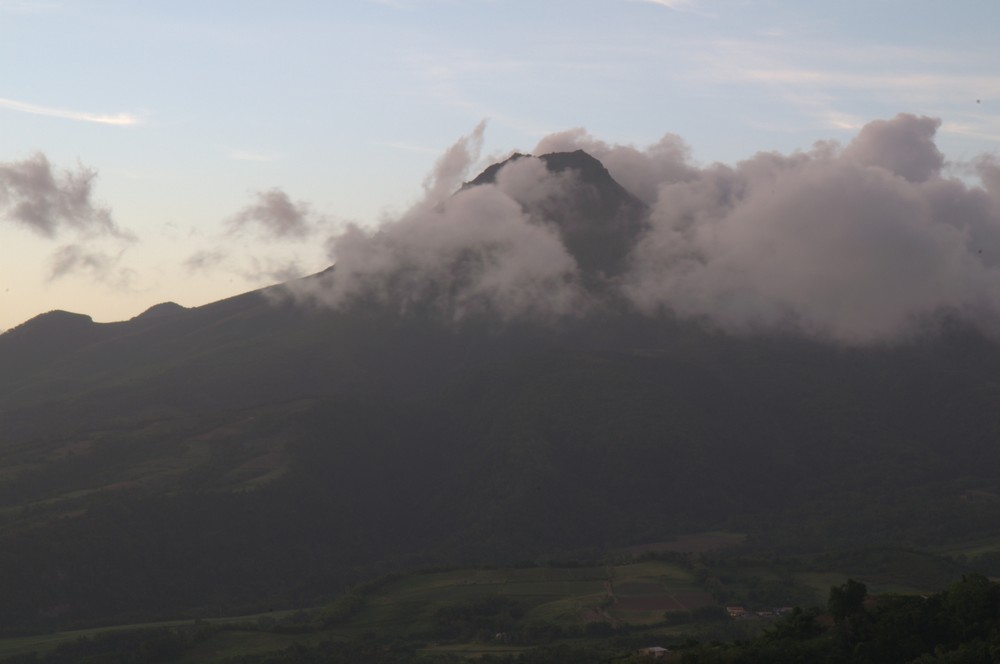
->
xmin=0 ymin=152 xmax=1000 ymax=630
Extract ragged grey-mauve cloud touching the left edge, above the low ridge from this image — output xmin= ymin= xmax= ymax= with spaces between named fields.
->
xmin=0 ymin=153 xmax=131 ymax=239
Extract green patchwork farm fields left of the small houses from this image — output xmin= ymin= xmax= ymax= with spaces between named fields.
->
xmin=0 ymin=561 xmax=712 ymax=663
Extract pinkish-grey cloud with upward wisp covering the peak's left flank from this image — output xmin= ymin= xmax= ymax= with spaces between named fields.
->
xmin=288 ymin=123 xmax=586 ymax=320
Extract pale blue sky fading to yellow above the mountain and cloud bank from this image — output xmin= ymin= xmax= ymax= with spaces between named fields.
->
xmin=0 ymin=0 xmax=1000 ymax=338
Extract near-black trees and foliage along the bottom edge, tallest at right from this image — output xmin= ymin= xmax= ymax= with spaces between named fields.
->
xmin=4 ymin=575 xmax=1000 ymax=664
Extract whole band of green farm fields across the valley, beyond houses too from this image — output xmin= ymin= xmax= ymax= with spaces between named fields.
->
xmin=0 ymin=540 xmax=976 ymax=664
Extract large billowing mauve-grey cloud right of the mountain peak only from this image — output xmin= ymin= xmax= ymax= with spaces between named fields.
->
xmin=623 ymin=114 xmax=1000 ymax=344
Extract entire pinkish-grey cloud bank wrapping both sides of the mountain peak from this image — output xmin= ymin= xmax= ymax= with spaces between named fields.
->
xmin=292 ymin=114 xmax=1000 ymax=344
